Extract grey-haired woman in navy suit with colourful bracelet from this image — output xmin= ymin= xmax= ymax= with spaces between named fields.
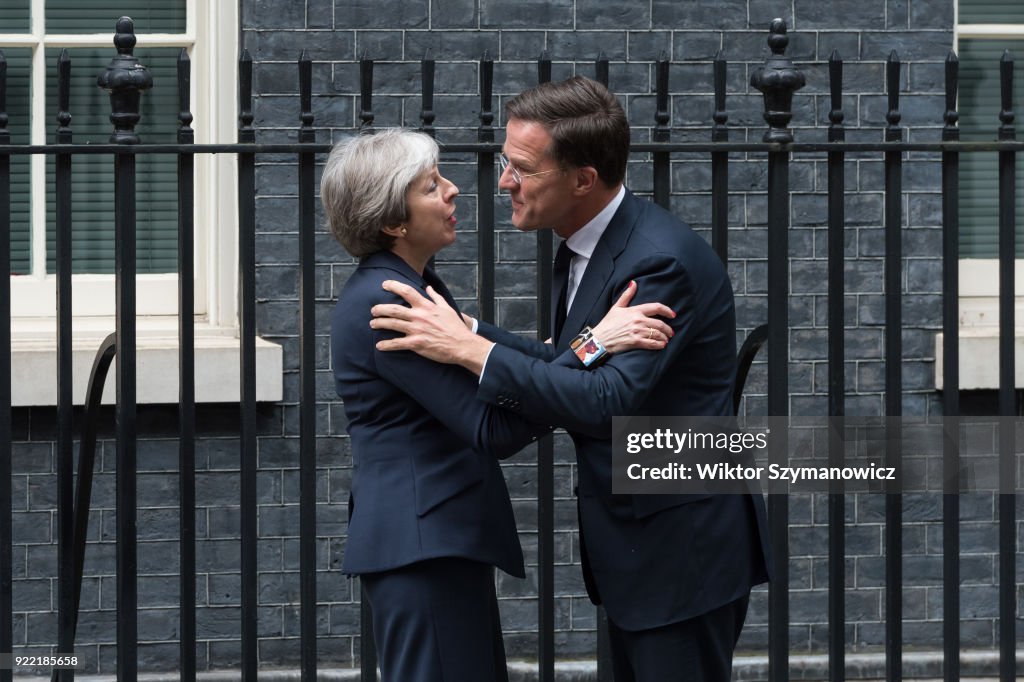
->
xmin=321 ymin=129 xmax=662 ymax=682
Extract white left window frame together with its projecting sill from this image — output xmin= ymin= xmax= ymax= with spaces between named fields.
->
xmin=6 ymin=0 xmax=283 ymax=406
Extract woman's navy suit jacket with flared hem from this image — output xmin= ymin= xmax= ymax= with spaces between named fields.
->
xmin=331 ymin=251 xmax=551 ymax=578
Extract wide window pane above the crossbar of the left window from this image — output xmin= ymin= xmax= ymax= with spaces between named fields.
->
xmin=44 ymin=0 xmax=185 ymax=36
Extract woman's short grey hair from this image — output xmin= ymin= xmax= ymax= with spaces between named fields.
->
xmin=321 ymin=128 xmax=438 ymax=258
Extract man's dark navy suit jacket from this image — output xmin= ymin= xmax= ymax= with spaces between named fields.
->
xmin=477 ymin=191 xmax=769 ymax=630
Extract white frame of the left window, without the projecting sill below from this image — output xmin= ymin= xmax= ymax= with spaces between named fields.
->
xmin=0 ymin=0 xmax=239 ymax=325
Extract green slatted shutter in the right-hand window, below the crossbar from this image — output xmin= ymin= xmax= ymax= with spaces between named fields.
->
xmin=959 ymin=39 xmax=1024 ymax=258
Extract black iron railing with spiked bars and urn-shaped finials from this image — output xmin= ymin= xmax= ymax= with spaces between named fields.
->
xmin=0 ymin=13 xmax=1024 ymax=682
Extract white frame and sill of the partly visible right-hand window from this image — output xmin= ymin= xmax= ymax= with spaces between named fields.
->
xmin=935 ymin=0 xmax=1024 ymax=390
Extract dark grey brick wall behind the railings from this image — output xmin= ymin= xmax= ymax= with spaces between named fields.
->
xmin=12 ymin=0 xmax=1024 ymax=673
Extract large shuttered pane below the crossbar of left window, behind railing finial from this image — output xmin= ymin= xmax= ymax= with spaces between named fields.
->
xmin=46 ymin=48 xmax=180 ymax=273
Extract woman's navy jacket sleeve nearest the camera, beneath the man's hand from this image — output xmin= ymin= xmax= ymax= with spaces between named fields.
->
xmin=373 ymin=307 xmax=553 ymax=458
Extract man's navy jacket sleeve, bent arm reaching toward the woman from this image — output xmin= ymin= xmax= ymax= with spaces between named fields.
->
xmin=477 ymin=255 xmax=716 ymax=437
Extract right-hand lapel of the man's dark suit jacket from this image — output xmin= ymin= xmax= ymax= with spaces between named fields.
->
xmin=555 ymin=189 xmax=642 ymax=350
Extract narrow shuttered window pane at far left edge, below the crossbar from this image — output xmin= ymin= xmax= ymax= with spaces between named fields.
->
xmin=3 ymin=47 xmax=32 ymax=274
